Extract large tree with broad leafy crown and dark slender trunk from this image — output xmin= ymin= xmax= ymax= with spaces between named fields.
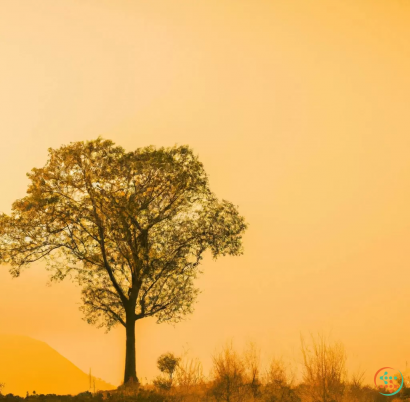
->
xmin=0 ymin=138 xmax=246 ymax=384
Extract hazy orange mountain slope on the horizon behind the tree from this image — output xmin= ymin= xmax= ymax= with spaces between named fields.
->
xmin=0 ymin=334 xmax=115 ymax=396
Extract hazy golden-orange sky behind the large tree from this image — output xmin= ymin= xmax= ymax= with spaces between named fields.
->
xmin=0 ymin=0 xmax=410 ymax=384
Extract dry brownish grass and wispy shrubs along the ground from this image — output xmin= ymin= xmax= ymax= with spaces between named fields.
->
xmin=0 ymin=336 xmax=410 ymax=402
